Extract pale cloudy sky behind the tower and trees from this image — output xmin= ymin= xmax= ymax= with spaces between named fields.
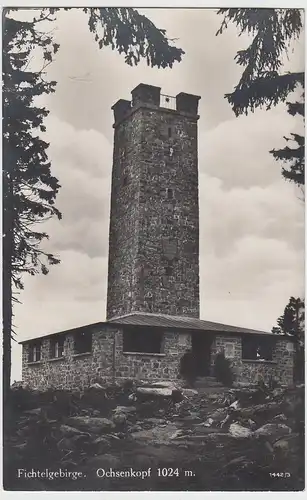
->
xmin=12 ymin=9 xmax=304 ymax=380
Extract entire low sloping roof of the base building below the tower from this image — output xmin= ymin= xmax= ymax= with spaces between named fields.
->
xmin=19 ymin=312 xmax=284 ymax=344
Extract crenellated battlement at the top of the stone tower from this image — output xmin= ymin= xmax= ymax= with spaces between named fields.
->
xmin=112 ymin=83 xmax=200 ymax=124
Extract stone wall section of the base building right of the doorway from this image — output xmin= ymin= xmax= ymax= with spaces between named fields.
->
xmin=211 ymin=335 xmax=294 ymax=385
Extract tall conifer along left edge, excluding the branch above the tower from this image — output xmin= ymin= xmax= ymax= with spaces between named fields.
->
xmin=3 ymin=15 xmax=61 ymax=402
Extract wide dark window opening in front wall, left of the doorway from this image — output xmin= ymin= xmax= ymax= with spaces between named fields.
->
xmin=123 ymin=326 xmax=163 ymax=354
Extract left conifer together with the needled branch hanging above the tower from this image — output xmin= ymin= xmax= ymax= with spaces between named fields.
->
xmin=2 ymin=8 xmax=184 ymax=400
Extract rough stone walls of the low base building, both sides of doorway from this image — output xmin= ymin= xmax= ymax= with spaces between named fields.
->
xmin=22 ymin=326 xmax=293 ymax=389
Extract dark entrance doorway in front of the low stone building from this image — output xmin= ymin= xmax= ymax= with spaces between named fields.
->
xmin=192 ymin=332 xmax=213 ymax=377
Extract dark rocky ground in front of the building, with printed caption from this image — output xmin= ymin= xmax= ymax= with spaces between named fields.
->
xmin=4 ymin=382 xmax=304 ymax=491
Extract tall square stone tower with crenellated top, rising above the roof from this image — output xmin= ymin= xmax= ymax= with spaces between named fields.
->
xmin=107 ymin=83 xmax=200 ymax=319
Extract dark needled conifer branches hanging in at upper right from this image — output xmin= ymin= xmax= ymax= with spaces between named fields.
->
xmin=217 ymin=8 xmax=305 ymax=186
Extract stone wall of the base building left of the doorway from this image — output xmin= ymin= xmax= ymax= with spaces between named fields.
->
xmin=22 ymin=327 xmax=191 ymax=390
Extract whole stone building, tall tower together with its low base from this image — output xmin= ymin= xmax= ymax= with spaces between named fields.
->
xmin=21 ymin=84 xmax=293 ymax=388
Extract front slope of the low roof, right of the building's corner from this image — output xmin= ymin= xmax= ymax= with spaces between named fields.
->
xmin=108 ymin=313 xmax=272 ymax=335
